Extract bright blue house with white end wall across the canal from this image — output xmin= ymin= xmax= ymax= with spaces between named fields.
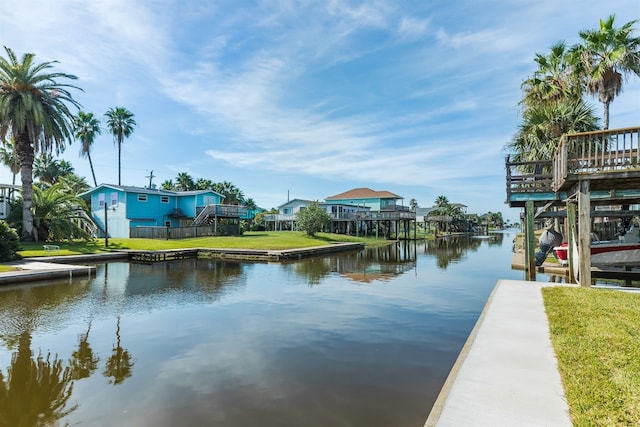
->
xmin=79 ymin=184 xmax=222 ymax=237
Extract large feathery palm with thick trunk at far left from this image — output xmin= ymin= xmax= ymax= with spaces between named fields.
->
xmin=0 ymin=47 xmax=80 ymax=239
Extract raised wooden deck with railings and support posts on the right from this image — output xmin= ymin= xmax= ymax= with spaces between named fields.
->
xmin=506 ymin=127 xmax=640 ymax=286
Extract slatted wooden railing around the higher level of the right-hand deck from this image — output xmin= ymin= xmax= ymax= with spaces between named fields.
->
xmin=553 ymin=127 xmax=640 ymax=191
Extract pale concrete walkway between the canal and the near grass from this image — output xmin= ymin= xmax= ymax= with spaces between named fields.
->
xmin=425 ymin=280 xmax=572 ymax=427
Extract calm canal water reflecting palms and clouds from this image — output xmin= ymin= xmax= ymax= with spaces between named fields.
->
xmin=0 ymin=233 xmax=523 ymax=427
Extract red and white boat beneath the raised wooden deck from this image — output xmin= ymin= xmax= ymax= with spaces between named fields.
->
xmin=553 ymin=227 xmax=640 ymax=267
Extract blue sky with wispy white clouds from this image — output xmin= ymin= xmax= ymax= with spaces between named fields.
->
xmin=0 ymin=0 xmax=640 ymax=221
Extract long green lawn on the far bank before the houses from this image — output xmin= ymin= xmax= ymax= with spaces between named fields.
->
xmin=18 ymin=231 xmax=390 ymax=257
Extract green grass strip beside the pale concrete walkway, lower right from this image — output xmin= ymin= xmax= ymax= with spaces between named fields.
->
xmin=543 ymin=287 xmax=640 ymax=426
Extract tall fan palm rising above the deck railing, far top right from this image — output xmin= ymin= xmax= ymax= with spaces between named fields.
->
xmin=572 ymin=15 xmax=640 ymax=129
